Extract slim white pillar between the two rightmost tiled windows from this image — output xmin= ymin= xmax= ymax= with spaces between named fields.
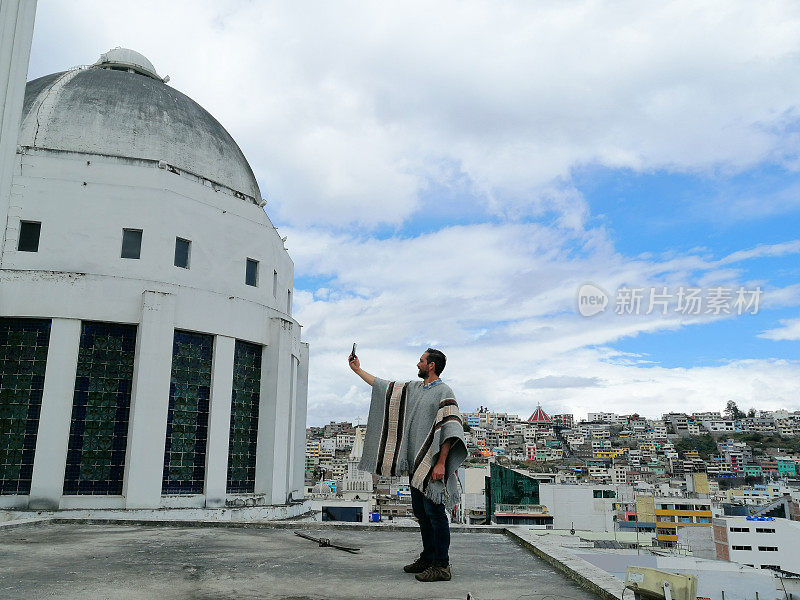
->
xmin=205 ymin=335 xmax=236 ymax=508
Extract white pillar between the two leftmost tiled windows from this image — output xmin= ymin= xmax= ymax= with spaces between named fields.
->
xmin=28 ymin=319 xmax=81 ymax=510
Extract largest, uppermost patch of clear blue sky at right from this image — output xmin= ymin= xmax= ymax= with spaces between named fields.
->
xmin=573 ymin=164 xmax=800 ymax=258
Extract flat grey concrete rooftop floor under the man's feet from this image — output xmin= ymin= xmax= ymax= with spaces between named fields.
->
xmin=0 ymin=523 xmax=597 ymax=600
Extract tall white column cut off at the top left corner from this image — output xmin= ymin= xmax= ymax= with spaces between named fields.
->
xmin=0 ymin=0 xmax=36 ymax=265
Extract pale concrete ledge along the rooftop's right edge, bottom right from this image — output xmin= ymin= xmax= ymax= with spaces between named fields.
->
xmin=504 ymin=527 xmax=625 ymax=600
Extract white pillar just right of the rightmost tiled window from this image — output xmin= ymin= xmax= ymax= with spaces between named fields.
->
xmin=255 ymin=318 xmax=293 ymax=504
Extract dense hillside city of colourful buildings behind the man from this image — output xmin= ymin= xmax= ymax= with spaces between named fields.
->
xmin=305 ymin=402 xmax=800 ymax=592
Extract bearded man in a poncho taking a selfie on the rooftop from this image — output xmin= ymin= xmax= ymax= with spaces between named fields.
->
xmin=349 ymin=348 xmax=467 ymax=581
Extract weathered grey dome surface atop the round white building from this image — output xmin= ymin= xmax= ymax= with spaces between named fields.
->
xmin=19 ymin=66 xmax=261 ymax=200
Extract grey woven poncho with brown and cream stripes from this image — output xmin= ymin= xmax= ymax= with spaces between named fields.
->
xmin=359 ymin=377 xmax=467 ymax=509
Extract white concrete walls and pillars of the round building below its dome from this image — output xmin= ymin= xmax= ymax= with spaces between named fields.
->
xmin=0 ymin=39 xmax=308 ymax=510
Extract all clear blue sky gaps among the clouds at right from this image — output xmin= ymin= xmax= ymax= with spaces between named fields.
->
xmin=574 ymin=164 xmax=800 ymax=367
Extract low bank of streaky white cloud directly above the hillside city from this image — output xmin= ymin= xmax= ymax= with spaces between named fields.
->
xmin=289 ymin=224 xmax=800 ymax=422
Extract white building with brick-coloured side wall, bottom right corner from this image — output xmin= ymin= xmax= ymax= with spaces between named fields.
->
xmin=714 ymin=517 xmax=800 ymax=575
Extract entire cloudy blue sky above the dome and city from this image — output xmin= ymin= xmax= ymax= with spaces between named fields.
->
xmin=30 ymin=0 xmax=800 ymax=425
